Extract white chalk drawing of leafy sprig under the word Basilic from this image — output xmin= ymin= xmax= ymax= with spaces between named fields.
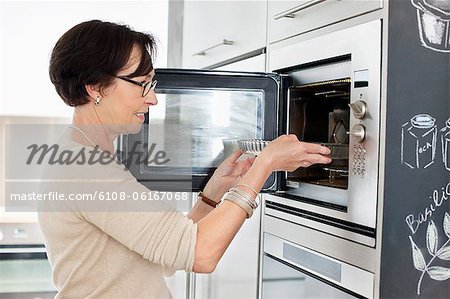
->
xmin=409 ymin=213 xmax=450 ymax=295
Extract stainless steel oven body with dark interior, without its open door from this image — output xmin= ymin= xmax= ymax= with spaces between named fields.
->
xmin=265 ymin=20 xmax=381 ymax=246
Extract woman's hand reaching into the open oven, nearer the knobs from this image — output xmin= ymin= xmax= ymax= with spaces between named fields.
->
xmin=258 ymin=135 xmax=331 ymax=171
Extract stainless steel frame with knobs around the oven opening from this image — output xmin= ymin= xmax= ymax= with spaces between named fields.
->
xmin=265 ymin=20 xmax=382 ymax=247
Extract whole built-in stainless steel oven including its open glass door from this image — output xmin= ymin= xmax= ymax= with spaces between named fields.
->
xmin=122 ymin=20 xmax=381 ymax=246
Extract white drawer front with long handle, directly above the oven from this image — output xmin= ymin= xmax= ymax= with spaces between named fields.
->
xmin=268 ymin=0 xmax=383 ymax=43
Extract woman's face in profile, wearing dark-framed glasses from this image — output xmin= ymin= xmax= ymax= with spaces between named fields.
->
xmin=101 ymin=47 xmax=158 ymax=134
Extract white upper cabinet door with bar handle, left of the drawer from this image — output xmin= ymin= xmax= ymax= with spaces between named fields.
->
xmin=182 ymin=1 xmax=267 ymax=69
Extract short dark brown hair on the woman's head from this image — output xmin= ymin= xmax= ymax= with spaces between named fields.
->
xmin=49 ymin=20 xmax=156 ymax=107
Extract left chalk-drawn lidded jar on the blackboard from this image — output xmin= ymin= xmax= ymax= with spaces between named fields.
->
xmin=401 ymin=114 xmax=437 ymax=169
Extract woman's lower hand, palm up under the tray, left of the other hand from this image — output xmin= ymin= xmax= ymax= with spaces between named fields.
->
xmin=203 ymin=150 xmax=255 ymax=202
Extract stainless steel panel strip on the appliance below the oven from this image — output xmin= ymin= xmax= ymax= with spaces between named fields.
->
xmin=263 ymin=215 xmax=377 ymax=273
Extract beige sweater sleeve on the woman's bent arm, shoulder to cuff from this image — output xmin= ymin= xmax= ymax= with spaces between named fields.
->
xmin=41 ymin=145 xmax=197 ymax=273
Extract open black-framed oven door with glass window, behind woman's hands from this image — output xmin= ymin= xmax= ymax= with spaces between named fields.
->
xmin=120 ymin=69 xmax=285 ymax=191
